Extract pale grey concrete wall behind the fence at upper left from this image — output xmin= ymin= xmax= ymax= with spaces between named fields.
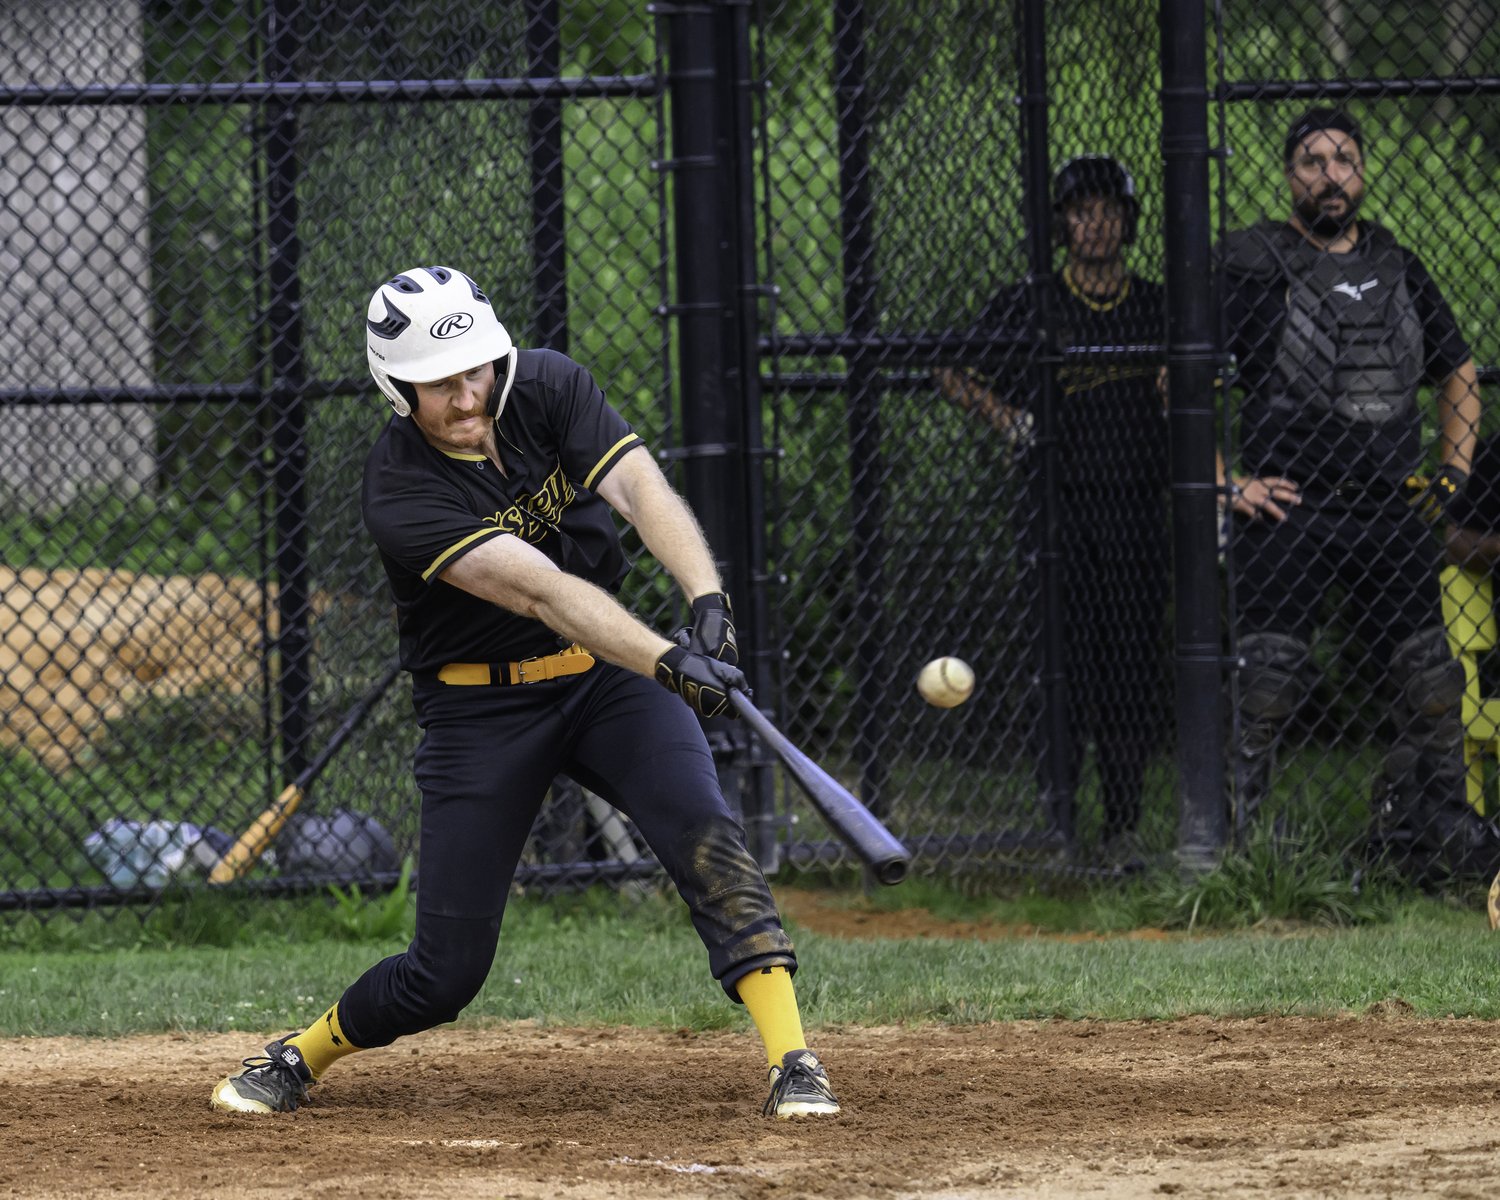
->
xmin=0 ymin=0 xmax=156 ymax=504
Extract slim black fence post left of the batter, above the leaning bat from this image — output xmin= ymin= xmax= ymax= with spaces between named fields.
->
xmin=266 ymin=0 xmax=312 ymax=782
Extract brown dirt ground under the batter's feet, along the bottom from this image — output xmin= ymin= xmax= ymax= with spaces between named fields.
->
xmin=0 ymin=1016 xmax=1500 ymax=1200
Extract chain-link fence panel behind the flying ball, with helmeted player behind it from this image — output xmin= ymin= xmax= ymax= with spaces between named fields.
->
xmin=761 ymin=0 xmax=1173 ymax=867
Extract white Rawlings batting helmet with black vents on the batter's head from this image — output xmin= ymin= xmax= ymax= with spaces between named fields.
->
xmin=365 ymin=267 xmax=516 ymax=417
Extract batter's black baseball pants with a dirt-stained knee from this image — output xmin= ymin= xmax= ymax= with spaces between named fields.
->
xmin=339 ymin=663 xmax=797 ymax=1049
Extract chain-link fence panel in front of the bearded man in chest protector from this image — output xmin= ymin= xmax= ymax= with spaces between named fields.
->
xmin=1214 ymin=0 xmax=1500 ymax=884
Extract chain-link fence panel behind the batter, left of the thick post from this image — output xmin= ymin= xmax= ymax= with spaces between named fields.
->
xmin=0 ymin=0 xmax=671 ymax=909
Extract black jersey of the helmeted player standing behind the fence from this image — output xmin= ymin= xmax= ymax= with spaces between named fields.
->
xmin=981 ymin=272 xmax=1167 ymax=488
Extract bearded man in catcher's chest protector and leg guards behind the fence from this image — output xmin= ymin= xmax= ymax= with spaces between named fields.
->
xmin=1221 ymin=110 xmax=1479 ymax=858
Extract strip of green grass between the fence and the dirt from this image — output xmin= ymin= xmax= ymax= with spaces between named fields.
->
xmin=0 ymin=887 xmax=1500 ymax=1037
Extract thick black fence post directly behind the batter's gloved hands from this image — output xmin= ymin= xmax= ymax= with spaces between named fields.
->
xmin=657 ymin=5 xmax=777 ymax=869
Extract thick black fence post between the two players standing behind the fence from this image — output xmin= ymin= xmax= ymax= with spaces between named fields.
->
xmin=1161 ymin=0 xmax=1229 ymax=872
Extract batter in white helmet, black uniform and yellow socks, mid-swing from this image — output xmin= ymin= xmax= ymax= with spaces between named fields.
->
xmin=212 ymin=267 xmax=839 ymax=1118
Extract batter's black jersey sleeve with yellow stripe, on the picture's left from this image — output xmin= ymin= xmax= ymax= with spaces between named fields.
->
xmin=360 ymin=417 xmax=507 ymax=584
